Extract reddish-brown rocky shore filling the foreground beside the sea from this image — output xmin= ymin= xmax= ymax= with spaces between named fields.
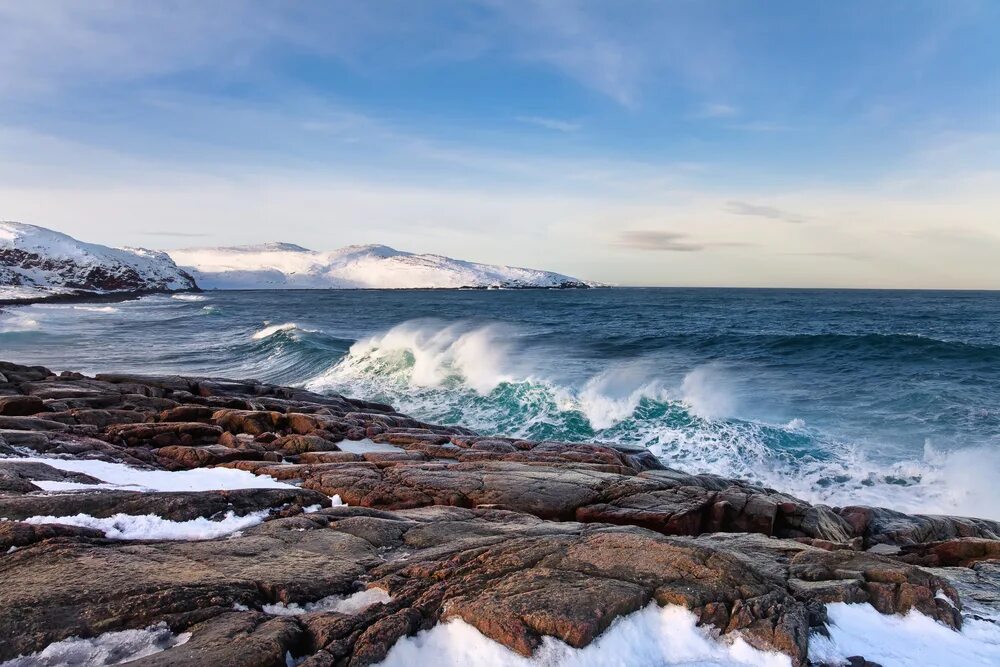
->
xmin=0 ymin=363 xmax=1000 ymax=666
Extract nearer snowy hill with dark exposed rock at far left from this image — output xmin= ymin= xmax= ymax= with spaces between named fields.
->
xmin=0 ymin=221 xmax=196 ymax=301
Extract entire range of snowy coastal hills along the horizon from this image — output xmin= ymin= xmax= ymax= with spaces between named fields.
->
xmin=0 ymin=222 xmax=596 ymax=303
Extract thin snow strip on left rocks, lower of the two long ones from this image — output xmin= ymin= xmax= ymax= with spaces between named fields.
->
xmin=23 ymin=510 xmax=269 ymax=540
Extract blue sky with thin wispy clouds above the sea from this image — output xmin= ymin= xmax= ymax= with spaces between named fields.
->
xmin=0 ymin=0 xmax=1000 ymax=289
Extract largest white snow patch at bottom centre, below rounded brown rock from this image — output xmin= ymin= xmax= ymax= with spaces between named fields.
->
xmin=379 ymin=603 xmax=791 ymax=667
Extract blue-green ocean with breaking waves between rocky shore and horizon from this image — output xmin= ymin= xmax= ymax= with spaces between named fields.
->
xmin=0 ymin=289 xmax=1000 ymax=518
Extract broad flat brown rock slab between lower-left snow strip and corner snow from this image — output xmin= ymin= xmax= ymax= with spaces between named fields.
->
xmin=0 ymin=519 xmax=378 ymax=664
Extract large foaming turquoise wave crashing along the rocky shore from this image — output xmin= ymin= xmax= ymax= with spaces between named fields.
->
xmin=304 ymin=320 xmax=1000 ymax=517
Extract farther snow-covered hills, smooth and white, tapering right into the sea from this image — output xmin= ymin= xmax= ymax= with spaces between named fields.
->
xmin=169 ymin=243 xmax=591 ymax=289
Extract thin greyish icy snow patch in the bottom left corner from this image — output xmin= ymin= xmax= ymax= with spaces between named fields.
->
xmin=0 ymin=623 xmax=191 ymax=667
